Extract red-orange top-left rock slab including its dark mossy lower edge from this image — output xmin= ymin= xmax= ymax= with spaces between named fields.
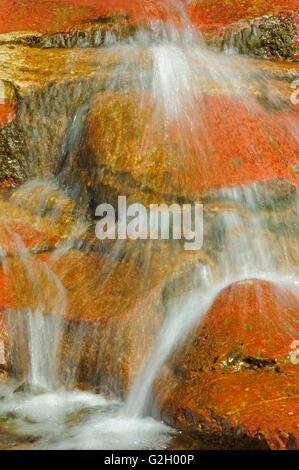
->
xmin=0 ymin=0 xmax=182 ymax=37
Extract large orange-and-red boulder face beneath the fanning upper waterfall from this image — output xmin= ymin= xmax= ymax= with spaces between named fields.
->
xmin=82 ymin=92 xmax=299 ymax=207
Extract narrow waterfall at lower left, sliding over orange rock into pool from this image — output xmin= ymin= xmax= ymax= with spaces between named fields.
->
xmin=2 ymin=223 xmax=66 ymax=389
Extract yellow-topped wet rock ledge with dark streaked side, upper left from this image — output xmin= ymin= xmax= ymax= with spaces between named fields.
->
xmin=0 ymin=45 xmax=150 ymax=183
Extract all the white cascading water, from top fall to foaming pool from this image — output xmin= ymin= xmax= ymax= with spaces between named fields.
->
xmin=0 ymin=1 xmax=299 ymax=449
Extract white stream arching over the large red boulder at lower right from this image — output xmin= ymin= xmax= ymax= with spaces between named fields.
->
xmin=124 ymin=262 xmax=299 ymax=417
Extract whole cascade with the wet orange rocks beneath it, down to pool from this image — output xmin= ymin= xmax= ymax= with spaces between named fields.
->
xmin=0 ymin=4 xmax=299 ymax=449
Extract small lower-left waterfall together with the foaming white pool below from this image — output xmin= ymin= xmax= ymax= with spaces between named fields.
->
xmin=0 ymin=216 xmax=176 ymax=449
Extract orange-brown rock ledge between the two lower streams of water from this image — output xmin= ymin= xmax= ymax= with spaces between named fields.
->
xmin=0 ymin=241 xmax=199 ymax=395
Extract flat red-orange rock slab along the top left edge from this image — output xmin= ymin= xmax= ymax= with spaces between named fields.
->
xmin=0 ymin=0 xmax=185 ymax=33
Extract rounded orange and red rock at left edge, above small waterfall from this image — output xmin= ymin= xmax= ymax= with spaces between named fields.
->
xmin=0 ymin=184 xmax=82 ymax=312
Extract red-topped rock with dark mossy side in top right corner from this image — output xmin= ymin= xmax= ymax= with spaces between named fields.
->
xmin=189 ymin=0 xmax=298 ymax=60
